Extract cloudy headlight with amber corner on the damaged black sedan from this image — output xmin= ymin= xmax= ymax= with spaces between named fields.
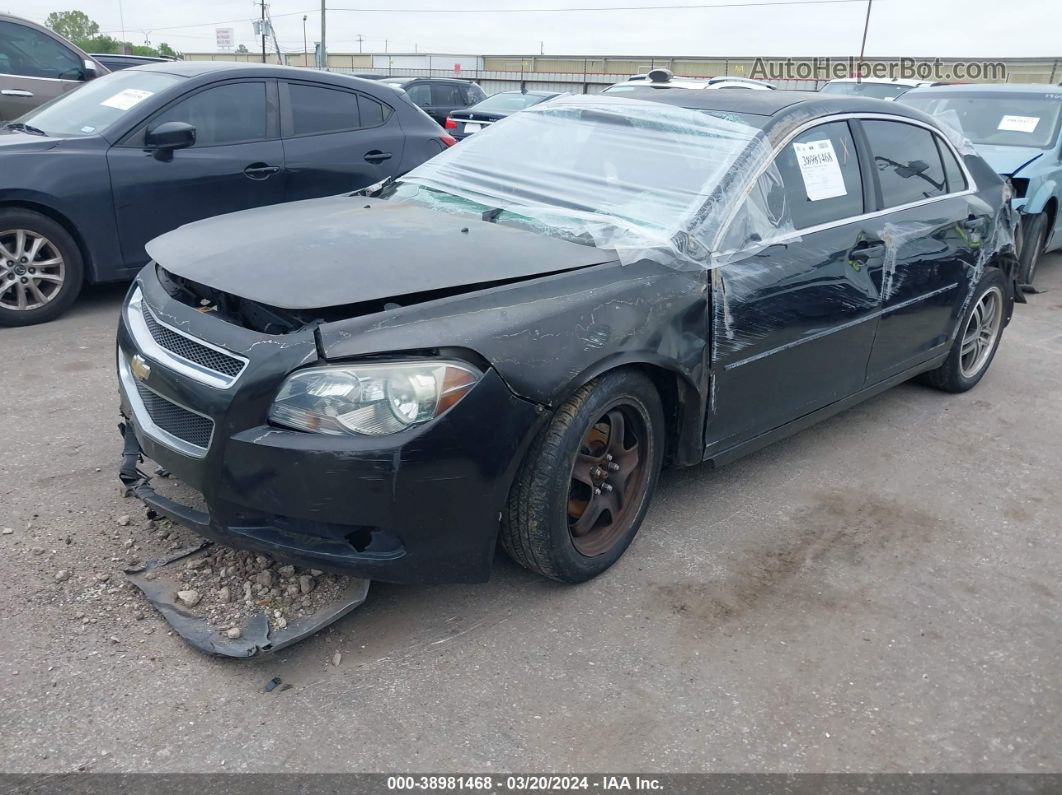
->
xmin=269 ymin=362 xmax=482 ymax=436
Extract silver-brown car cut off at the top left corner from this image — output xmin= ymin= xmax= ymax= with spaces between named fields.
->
xmin=0 ymin=14 xmax=108 ymax=122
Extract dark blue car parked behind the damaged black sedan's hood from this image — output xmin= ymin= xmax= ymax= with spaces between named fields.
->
xmin=0 ymin=62 xmax=456 ymax=326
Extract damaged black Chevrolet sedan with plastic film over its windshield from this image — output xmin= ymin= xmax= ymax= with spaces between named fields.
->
xmin=118 ymin=89 xmax=1021 ymax=583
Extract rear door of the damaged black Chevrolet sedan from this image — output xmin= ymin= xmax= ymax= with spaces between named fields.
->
xmin=858 ymin=119 xmax=992 ymax=383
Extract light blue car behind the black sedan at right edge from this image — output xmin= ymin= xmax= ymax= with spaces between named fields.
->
xmin=897 ymin=84 xmax=1062 ymax=284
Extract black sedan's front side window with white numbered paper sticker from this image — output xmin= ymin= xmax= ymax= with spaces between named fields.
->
xmin=774 ymin=121 xmax=863 ymax=229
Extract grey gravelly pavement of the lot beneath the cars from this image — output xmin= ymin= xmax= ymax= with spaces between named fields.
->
xmin=0 ymin=256 xmax=1062 ymax=772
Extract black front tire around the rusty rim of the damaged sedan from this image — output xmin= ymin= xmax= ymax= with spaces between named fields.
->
xmin=501 ymin=369 xmax=665 ymax=583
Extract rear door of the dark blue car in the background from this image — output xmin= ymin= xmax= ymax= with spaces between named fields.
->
xmin=280 ymin=81 xmax=405 ymax=201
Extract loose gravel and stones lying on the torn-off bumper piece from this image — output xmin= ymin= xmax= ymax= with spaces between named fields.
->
xmin=162 ymin=545 xmax=350 ymax=639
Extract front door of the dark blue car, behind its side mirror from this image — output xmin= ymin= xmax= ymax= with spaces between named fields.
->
xmin=107 ymin=80 xmax=285 ymax=266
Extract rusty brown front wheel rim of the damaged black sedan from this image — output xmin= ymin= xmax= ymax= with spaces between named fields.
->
xmin=568 ymin=403 xmax=649 ymax=557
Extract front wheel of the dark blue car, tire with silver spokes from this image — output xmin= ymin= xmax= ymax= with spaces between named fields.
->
xmin=0 ymin=208 xmax=85 ymax=326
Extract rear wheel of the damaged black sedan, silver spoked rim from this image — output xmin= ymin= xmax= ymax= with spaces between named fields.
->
xmin=921 ymin=267 xmax=1008 ymax=393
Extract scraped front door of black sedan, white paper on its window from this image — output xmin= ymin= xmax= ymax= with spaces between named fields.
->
xmin=705 ymin=121 xmax=884 ymax=454
